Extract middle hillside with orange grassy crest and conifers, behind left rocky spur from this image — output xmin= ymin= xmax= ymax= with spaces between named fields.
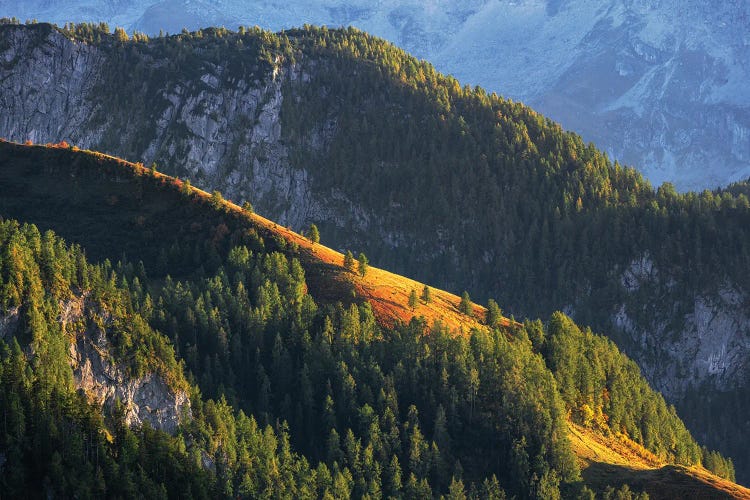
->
xmin=0 ymin=143 xmax=744 ymax=498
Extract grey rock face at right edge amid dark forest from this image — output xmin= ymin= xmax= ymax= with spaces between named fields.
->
xmin=612 ymin=255 xmax=750 ymax=401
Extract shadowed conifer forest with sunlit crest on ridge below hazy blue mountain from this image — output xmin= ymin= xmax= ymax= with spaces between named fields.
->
xmin=0 ymin=24 xmax=750 ymax=477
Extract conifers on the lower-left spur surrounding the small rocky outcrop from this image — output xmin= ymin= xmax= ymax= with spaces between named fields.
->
xmin=0 ymin=221 xmax=317 ymax=498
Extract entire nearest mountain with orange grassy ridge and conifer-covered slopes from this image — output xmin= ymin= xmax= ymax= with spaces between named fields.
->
xmin=0 ymin=142 xmax=750 ymax=498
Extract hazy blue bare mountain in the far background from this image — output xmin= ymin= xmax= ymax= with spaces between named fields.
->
xmin=0 ymin=0 xmax=750 ymax=191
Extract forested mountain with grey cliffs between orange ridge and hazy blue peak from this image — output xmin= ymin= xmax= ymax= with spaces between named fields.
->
xmin=0 ymin=24 xmax=750 ymax=477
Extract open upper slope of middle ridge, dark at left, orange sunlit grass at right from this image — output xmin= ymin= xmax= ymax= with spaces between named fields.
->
xmin=0 ymin=142 xmax=500 ymax=331
